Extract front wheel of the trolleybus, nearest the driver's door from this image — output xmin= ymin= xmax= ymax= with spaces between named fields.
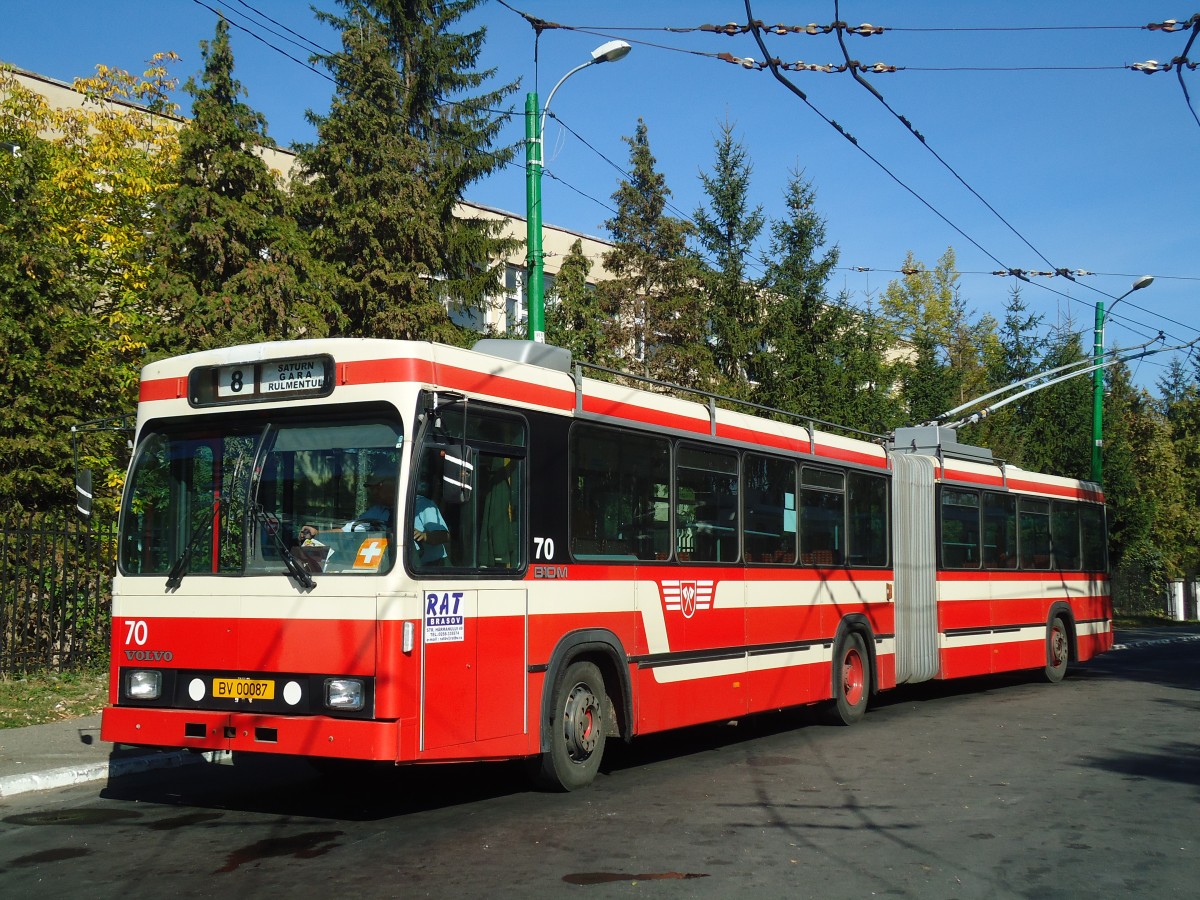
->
xmin=534 ymin=662 xmax=608 ymax=791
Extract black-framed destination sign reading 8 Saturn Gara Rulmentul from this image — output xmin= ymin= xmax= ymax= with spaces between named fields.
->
xmin=191 ymin=355 xmax=334 ymax=406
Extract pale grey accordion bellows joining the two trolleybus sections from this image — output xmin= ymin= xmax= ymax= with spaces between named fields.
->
xmin=892 ymin=454 xmax=940 ymax=684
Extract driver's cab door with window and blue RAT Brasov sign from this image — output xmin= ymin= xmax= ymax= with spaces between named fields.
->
xmin=415 ymin=398 xmax=528 ymax=750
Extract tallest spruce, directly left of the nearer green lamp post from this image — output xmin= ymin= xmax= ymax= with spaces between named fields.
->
xmin=298 ymin=0 xmax=517 ymax=343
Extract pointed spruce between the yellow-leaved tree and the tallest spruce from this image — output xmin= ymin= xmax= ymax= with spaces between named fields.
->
xmin=150 ymin=18 xmax=337 ymax=354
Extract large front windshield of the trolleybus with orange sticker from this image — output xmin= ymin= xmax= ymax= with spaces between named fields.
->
xmin=120 ymin=415 xmax=403 ymax=587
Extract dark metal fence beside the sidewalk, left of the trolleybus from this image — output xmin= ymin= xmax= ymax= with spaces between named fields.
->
xmin=0 ymin=514 xmax=116 ymax=676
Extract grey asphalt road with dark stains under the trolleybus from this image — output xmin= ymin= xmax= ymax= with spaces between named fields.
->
xmin=0 ymin=643 xmax=1200 ymax=900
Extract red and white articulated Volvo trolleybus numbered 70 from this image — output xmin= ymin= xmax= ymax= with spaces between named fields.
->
xmin=102 ymin=340 xmax=1112 ymax=790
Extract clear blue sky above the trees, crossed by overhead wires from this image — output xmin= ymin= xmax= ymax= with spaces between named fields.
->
xmin=0 ymin=0 xmax=1200 ymax=385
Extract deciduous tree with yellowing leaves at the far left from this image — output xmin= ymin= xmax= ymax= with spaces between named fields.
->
xmin=0 ymin=61 xmax=176 ymax=509
